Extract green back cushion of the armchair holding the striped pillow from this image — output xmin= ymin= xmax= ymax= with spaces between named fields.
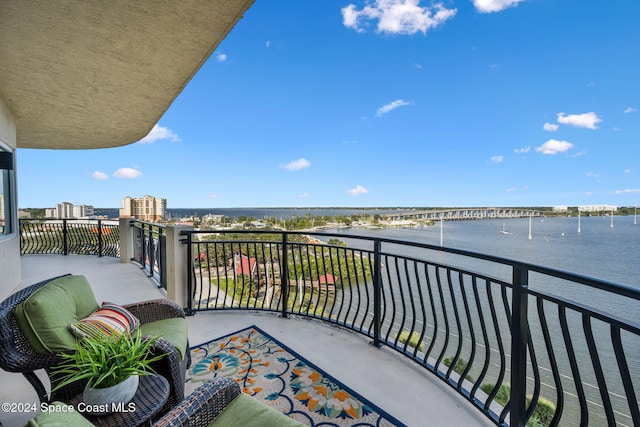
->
xmin=14 ymin=276 xmax=99 ymax=354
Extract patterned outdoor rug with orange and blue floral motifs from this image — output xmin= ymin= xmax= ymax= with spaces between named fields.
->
xmin=185 ymin=326 xmax=404 ymax=427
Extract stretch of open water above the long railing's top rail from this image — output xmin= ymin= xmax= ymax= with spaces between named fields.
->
xmin=332 ymin=216 xmax=640 ymax=288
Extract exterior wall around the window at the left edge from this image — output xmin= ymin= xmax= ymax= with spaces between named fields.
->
xmin=0 ymin=99 xmax=22 ymax=299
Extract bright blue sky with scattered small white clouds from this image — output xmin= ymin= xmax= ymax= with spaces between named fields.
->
xmin=18 ymin=0 xmax=640 ymax=208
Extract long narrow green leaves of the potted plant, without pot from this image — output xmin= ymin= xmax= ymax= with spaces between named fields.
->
xmin=52 ymin=331 xmax=164 ymax=391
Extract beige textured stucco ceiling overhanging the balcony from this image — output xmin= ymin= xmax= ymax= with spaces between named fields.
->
xmin=0 ymin=0 xmax=254 ymax=149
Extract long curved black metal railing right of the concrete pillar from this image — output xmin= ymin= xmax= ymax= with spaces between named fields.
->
xmin=184 ymin=231 xmax=640 ymax=426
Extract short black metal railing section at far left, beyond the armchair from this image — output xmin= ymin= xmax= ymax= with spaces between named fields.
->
xmin=20 ymin=219 xmax=120 ymax=257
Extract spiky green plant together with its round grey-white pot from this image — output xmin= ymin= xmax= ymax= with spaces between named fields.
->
xmin=52 ymin=331 xmax=164 ymax=412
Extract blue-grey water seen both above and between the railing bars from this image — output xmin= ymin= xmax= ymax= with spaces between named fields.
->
xmin=324 ymin=216 xmax=640 ymax=426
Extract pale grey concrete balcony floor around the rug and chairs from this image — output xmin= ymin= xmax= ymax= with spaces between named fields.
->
xmin=0 ymin=255 xmax=494 ymax=427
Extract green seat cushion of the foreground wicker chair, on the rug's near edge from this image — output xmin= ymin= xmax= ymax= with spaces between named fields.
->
xmin=209 ymin=393 xmax=304 ymax=427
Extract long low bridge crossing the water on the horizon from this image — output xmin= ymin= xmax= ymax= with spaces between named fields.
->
xmin=380 ymin=208 xmax=544 ymax=221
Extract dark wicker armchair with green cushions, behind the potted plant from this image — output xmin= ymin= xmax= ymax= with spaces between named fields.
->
xmin=0 ymin=275 xmax=191 ymax=413
